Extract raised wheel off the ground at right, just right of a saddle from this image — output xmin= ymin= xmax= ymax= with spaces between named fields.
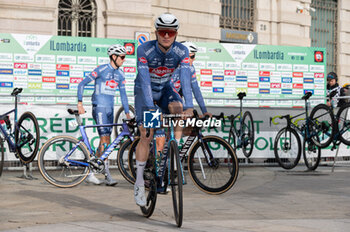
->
xmin=308 ymin=104 xmax=335 ymax=148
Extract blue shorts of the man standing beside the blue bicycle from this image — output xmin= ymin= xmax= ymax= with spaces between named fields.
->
xmin=92 ymin=105 xmax=114 ymax=137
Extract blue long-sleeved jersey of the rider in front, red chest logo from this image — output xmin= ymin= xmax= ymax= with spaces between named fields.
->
xmin=135 ymin=40 xmax=193 ymax=109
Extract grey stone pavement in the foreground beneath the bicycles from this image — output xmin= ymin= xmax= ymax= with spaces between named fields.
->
xmin=0 ymin=167 xmax=350 ymax=232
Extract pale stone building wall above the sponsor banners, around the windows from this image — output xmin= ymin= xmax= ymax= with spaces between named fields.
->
xmin=0 ymin=0 xmax=350 ymax=84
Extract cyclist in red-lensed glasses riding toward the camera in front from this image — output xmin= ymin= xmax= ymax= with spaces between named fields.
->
xmin=134 ymin=13 xmax=193 ymax=206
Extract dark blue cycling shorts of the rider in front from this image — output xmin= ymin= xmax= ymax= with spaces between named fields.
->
xmin=134 ymin=82 xmax=182 ymax=125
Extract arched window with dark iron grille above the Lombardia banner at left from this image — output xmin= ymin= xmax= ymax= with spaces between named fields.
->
xmin=57 ymin=0 xmax=97 ymax=37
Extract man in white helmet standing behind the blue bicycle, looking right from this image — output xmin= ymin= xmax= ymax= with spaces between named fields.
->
xmin=78 ymin=44 xmax=131 ymax=186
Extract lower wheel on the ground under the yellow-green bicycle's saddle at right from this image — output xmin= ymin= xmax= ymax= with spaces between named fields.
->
xmin=303 ymin=138 xmax=321 ymax=171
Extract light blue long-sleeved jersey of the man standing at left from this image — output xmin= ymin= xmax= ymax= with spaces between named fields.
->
xmin=78 ymin=64 xmax=129 ymax=113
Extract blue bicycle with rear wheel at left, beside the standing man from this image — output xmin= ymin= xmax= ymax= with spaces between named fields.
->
xmin=38 ymin=109 xmax=135 ymax=188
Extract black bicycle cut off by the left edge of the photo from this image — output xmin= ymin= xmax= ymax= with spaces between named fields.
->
xmin=0 ymin=88 xmax=40 ymax=175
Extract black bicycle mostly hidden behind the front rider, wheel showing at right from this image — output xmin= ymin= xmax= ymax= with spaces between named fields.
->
xmin=119 ymin=111 xmax=239 ymax=195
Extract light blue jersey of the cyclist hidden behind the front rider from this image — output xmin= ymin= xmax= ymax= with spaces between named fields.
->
xmin=172 ymin=65 xmax=207 ymax=114
